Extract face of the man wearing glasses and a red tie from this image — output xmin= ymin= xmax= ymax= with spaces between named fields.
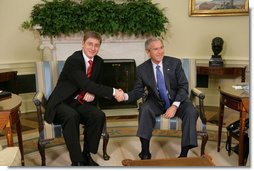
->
xmin=83 ymin=38 xmax=101 ymax=58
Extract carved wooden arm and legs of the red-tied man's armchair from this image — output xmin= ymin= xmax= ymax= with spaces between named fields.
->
xmin=33 ymin=92 xmax=110 ymax=166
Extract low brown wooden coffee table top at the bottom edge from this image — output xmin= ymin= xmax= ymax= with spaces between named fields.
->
xmin=122 ymin=155 xmax=215 ymax=166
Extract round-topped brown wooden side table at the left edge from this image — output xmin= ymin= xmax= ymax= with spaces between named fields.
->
xmin=0 ymin=94 xmax=25 ymax=166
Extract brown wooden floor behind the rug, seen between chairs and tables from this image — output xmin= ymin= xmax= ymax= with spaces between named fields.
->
xmin=0 ymin=108 xmax=239 ymax=158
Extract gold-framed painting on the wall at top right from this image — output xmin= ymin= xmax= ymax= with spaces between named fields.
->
xmin=189 ymin=0 xmax=249 ymax=16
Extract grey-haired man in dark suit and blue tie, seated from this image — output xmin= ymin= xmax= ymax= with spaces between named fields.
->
xmin=117 ymin=38 xmax=198 ymax=159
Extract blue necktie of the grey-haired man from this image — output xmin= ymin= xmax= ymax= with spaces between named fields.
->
xmin=156 ymin=65 xmax=170 ymax=109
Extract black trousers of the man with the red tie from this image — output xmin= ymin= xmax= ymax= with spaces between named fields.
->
xmin=53 ymin=101 xmax=105 ymax=162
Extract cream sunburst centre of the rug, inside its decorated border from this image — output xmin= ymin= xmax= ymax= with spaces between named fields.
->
xmin=25 ymin=136 xmax=246 ymax=167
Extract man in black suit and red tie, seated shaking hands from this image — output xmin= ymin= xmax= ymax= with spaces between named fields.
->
xmin=45 ymin=31 xmax=122 ymax=166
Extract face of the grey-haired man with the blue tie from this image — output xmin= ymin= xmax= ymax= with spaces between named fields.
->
xmin=146 ymin=40 xmax=164 ymax=64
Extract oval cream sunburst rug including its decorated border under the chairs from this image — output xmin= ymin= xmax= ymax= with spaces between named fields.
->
xmin=24 ymin=127 xmax=242 ymax=167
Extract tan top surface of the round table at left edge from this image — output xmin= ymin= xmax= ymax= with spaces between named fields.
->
xmin=0 ymin=94 xmax=22 ymax=111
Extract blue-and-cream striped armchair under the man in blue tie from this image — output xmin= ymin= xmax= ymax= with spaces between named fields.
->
xmin=142 ymin=58 xmax=208 ymax=155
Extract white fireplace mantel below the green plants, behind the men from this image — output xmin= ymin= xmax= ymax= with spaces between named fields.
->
xmin=40 ymin=34 xmax=148 ymax=65
